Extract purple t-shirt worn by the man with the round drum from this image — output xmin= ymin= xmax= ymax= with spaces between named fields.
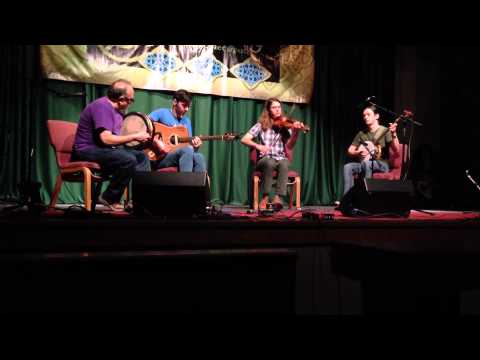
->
xmin=73 ymin=96 xmax=123 ymax=151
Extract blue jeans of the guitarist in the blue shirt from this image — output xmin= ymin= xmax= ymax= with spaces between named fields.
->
xmin=152 ymin=145 xmax=207 ymax=172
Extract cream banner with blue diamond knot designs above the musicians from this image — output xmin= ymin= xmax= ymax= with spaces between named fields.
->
xmin=41 ymin=45 xmax=314 ymax=103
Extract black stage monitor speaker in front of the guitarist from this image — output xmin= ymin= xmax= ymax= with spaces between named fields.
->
xmin=132 ymin=171 xmax=210 ymax=218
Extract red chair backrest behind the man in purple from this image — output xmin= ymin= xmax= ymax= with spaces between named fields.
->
xmin=47 ymin=120 xmax=78 ymax=167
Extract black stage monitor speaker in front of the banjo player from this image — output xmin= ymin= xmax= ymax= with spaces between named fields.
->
xmin=340 ymin=179 xmax=414 ymax=217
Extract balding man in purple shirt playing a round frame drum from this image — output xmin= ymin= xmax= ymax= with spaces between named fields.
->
xmin=72 ymin=79 xmax=150 ymax=211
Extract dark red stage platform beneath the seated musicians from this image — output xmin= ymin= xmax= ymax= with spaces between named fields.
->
xmin=0 ymin=205 xmax=480 ymax=253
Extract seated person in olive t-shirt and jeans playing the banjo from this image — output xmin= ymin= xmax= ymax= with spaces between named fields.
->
xmin=343 ymin=105 xmax=400 ymax=194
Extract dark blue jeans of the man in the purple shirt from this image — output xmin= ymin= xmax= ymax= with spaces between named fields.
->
xmin=72 ymin=147 xmax=151 ymax=204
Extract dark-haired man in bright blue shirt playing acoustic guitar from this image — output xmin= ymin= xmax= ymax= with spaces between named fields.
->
xmin=149 ymin=90 xmax=207 ymax=172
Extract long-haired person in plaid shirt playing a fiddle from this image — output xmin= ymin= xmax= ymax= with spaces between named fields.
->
xmin=241 ymin=98 xmax=304 ymax=210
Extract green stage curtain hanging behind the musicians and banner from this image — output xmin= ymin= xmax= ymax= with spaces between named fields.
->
xmin=0 ymin=45 xmax=394 ymax=206
